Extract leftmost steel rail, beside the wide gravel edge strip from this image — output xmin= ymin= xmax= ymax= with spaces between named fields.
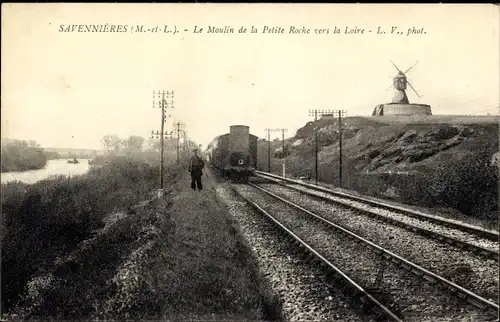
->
xmin=231 ymin=185 xmax=403 ymax=322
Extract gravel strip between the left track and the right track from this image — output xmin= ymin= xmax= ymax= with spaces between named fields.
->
xmin=259 ymin=184 xmax=498 ymax=302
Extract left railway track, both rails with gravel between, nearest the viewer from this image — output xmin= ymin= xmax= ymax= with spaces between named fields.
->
xmin=233 ymin=183 xmax=498 ymax=321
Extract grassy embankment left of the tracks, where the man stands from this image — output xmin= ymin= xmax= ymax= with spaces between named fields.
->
xmin=2 ymin=155 xmax=278 ymax=319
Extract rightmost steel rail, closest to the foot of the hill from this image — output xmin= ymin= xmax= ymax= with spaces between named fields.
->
xmin=255 ymin=171 xmax=500 ymax=241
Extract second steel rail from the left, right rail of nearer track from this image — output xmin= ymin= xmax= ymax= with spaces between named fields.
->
xmin=248 ymin=183 xmax=499 ymax=316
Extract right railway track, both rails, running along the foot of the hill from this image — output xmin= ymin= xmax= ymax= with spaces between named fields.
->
xmin=257 ymin=171 xmax=499 ymax=262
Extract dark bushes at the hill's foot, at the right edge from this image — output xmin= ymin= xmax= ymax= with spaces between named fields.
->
xmin=374 ymin=142 xmax=498 ymax=219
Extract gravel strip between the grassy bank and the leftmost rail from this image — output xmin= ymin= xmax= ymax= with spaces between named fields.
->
xmin=216 ymin=185 xmax=373 ymax=322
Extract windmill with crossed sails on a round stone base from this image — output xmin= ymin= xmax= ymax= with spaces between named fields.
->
xmin=372 ymin=60 xmax=432 ymax=116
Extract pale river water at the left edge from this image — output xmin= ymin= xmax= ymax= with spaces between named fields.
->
xmin=1 ymin=159 xmax=90 ymax=184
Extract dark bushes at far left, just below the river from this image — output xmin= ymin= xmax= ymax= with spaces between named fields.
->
xmin=1 ymin=158 xmax=158 ymax=311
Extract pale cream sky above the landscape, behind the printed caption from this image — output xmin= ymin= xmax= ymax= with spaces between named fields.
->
xmin=1 ymin=3 xmax=500 ymax=149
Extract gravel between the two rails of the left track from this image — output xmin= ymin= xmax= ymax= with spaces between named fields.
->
xmin=233 ymin=186 xmax=492 ymax=321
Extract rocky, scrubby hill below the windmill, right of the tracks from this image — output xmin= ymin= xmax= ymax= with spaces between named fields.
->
xmin=258 ymin=116 xmax=499 ymax=224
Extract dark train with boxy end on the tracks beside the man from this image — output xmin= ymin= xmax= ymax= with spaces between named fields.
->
xmin=205 ymin=125 xmax=257 ymax=182
